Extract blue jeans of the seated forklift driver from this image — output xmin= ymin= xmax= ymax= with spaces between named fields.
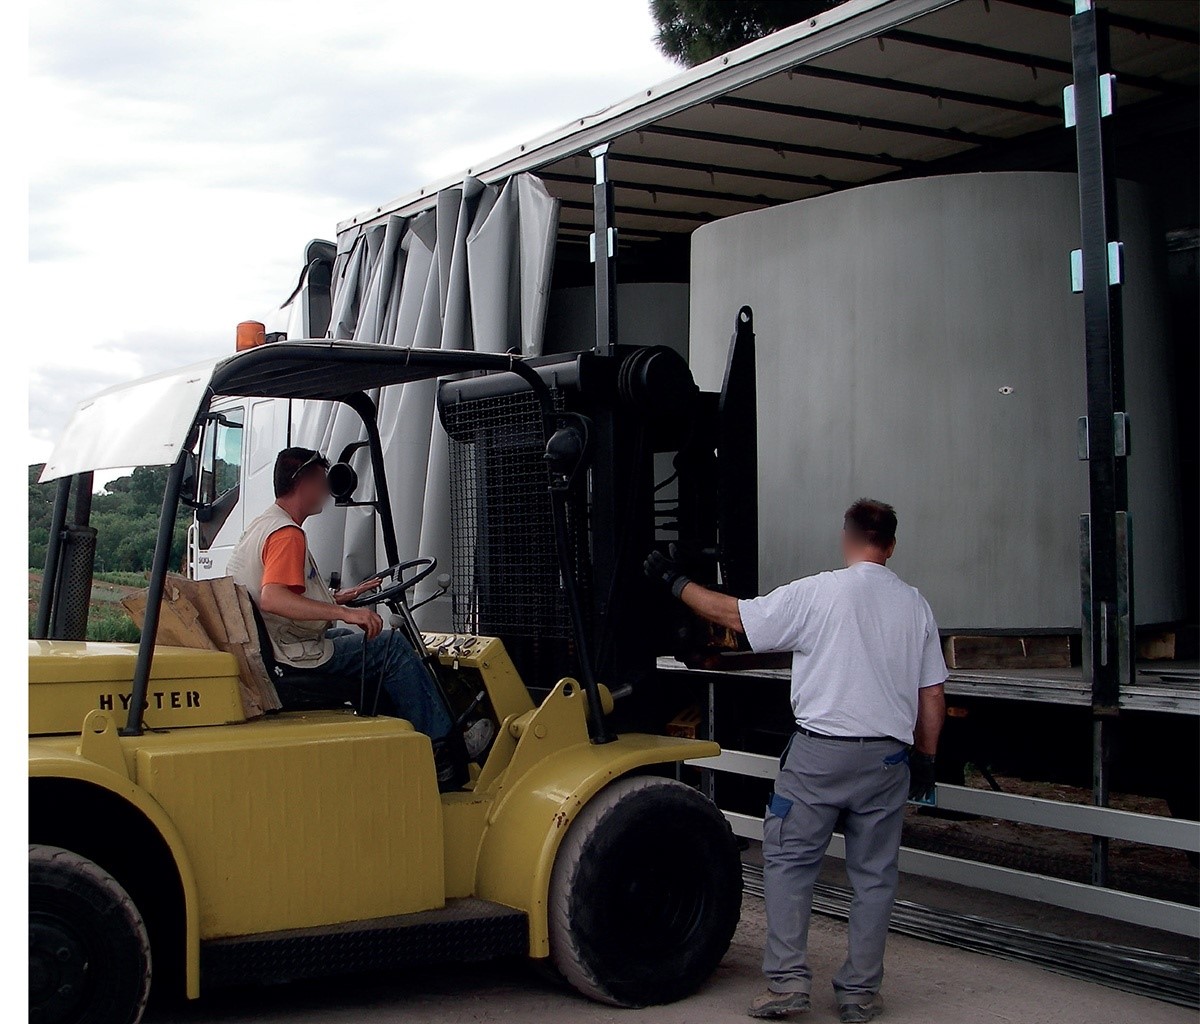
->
xmin=275 ymin=627 xmax=452 ymax=739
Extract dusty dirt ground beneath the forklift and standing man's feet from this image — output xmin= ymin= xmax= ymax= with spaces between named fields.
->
xmin=146 ymin=896 xmax=1196 ymax=1024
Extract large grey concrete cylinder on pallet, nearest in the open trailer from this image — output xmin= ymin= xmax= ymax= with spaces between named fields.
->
xmin=690 ymin=173 xmax=1182 ymax=629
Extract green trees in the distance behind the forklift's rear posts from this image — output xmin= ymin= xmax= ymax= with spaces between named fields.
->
xmin=29 ymin=466 xmax=191 ymax=576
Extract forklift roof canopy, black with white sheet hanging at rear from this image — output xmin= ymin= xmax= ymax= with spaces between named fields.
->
xmin=41 ymin=341 xmax=532 ymax=483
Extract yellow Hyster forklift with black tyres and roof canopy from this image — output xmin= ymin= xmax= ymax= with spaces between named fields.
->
xmin=29 ymin=341 xmax=742 ymax=1024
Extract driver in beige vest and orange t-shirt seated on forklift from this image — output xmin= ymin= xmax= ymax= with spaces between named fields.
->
xmin=228 ymin=448 xmax=451 ymax=747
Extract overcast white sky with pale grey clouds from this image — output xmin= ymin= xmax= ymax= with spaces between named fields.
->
xmin=25 ymin=0 xmax=679 ymax=462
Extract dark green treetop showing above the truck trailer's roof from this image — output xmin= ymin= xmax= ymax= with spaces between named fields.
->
xmin=650 ymin=0 xmax=844 ymax=67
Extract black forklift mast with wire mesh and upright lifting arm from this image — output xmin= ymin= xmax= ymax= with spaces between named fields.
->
xmin=438 ymin=307 xmax=758 ymax=689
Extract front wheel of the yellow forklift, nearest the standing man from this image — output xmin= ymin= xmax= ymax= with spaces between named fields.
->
xmin=548 ymin=777 xmax=742 ymax=1006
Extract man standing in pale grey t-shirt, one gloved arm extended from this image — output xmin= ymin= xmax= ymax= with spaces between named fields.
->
xmin=646 ymin=498 xmax=948 ymax=1024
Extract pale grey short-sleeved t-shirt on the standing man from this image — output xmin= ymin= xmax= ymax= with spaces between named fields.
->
xmin=738 ymin=562 xmax=948 ymax=743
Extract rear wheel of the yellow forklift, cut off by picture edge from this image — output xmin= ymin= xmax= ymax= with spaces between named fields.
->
xmin=29 ymin=846 xmax=150 ymax=1024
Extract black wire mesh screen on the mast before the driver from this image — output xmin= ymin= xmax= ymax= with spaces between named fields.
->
xmin=443 ymin=391 xmax=581 ymax=639
